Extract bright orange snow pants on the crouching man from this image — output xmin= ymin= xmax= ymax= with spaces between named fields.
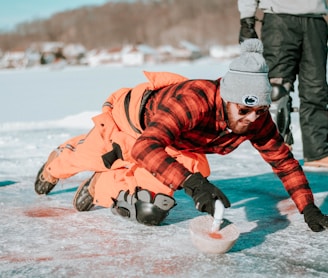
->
xmin=47 ymin=73 xmax=210 ymax=207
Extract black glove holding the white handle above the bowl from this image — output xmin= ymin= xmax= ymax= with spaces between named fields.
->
xmin=183 ymin=173 xmax=231 ymax=216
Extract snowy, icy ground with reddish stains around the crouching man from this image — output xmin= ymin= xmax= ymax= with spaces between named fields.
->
xmin=0 ymin=59 xmax=328 ymax=277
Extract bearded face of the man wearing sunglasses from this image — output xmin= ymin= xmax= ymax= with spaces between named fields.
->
xmin=226 ymin=102 xmax=270 ymax=134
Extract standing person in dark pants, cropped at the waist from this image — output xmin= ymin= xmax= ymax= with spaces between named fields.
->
xmin=238 ymin=0 xmax=328 ymax=171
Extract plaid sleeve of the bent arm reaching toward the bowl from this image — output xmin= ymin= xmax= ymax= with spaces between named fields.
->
xmin=131 ymin=79 xmax=216 ymax=190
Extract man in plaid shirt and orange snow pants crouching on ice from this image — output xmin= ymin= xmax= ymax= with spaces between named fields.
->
xmin=35 ymin=39 xmax=328 ymax=232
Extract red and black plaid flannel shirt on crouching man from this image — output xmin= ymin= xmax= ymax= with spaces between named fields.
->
xmin=132 ymin=77 xmax=313 ymax=212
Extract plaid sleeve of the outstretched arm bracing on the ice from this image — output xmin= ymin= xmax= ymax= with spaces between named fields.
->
xmin=251 ymin=113 xmax=314 ymax=213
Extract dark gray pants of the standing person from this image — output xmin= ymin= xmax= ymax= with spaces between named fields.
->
xmin=261 ymin=14 xmax=328 ymax=161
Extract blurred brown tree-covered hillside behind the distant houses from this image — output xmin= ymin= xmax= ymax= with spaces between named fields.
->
xmin=0 ymin=0 xmax=239 ymax=51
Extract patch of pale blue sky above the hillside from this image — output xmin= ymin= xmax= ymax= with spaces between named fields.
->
xmin=0 ymin=0 xmax=114 ymax=30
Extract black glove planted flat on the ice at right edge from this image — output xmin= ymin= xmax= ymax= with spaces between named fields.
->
xmin=303 ymin=203 xmax=328 ymax=232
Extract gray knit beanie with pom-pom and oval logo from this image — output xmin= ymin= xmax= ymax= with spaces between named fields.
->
xmin=220 ymin=39 xmax=272 ymax=106
